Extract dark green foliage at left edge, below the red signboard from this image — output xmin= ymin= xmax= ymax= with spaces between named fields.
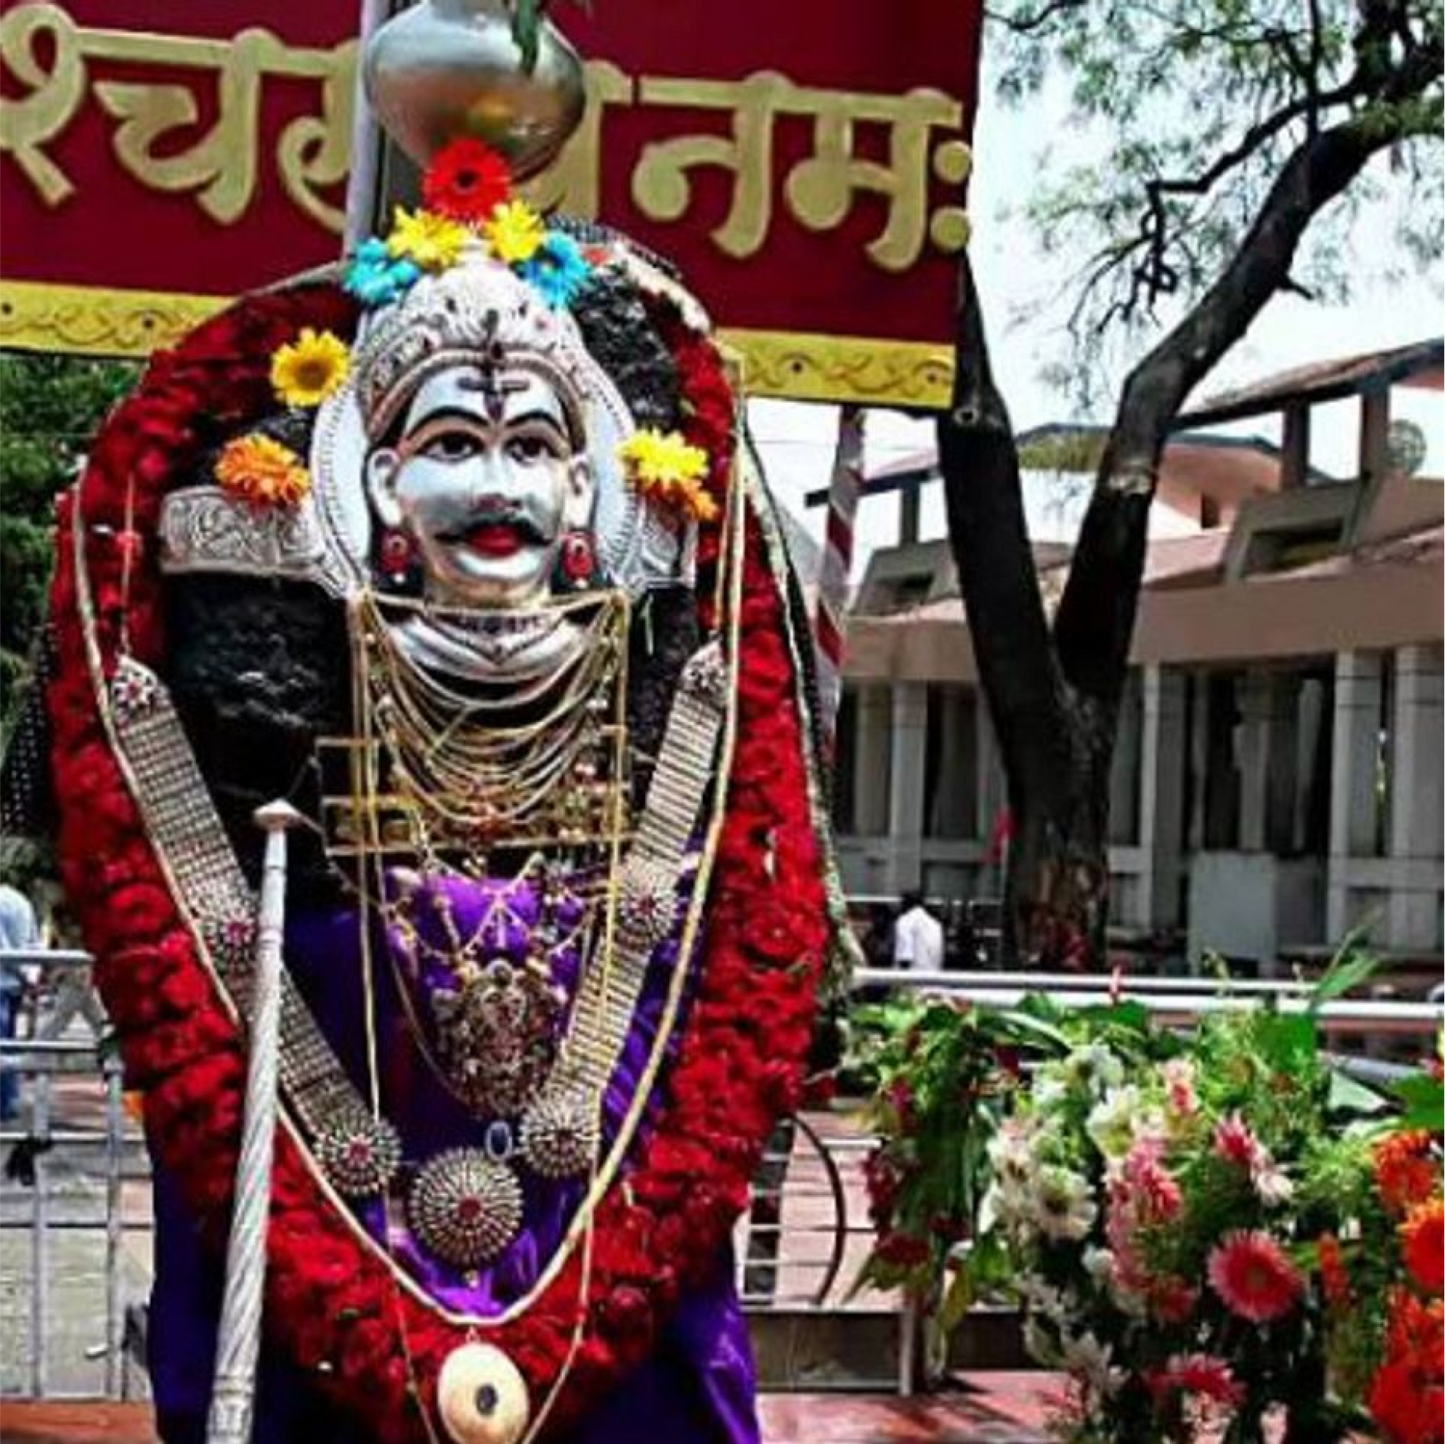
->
xmin=0 ymin=356 xmax=134 ymax=737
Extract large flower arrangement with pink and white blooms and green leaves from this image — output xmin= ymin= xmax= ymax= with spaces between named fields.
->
xmin=868 ymin=961 xmax=1421 ymax=1444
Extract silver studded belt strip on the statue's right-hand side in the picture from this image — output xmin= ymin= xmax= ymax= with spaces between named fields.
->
xmin=522 ymin=643 xmax=728 ymax=1177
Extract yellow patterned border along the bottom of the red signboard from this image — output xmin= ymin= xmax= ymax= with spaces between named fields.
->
xmin=0 ymin=280 xmax=954 ymax=408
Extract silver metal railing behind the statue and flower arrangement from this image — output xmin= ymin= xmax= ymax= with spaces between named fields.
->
xmin=0 ymin=953 xmax=1445 ymax=1399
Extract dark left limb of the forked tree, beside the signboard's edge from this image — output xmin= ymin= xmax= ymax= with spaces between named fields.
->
xmin=938 ymin=256 xmax=1068 ymax=789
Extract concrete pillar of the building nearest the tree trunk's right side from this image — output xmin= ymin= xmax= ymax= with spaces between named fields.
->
xmin=1139 ymin=666 xmax=1188 ymax=928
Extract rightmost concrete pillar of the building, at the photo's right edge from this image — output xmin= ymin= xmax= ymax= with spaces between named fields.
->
xmin=1389 ymin=646 xmax=1445 ymax=951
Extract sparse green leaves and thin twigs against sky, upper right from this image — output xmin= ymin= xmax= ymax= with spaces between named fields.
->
xmin=988 ymin=0 xmax=1445 ymax=401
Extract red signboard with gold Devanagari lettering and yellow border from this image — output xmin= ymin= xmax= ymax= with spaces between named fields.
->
xmin=0 ymin=0 xmax=981 ymax=403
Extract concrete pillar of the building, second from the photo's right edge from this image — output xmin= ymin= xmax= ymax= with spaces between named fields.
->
xmin=1329 ymin=652 xmax=1384 ymax=941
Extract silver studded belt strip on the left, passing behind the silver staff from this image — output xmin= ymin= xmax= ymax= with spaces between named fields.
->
xmin=111 ymin=658 xmax=400 ymax=1198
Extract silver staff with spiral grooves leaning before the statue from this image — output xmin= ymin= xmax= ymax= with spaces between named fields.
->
xmin=207 ymin=802 xmax=302 ymax=1444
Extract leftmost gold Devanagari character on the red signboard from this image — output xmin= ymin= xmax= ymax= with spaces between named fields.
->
xmin=0 ymin=4 xmax=87 ymax=205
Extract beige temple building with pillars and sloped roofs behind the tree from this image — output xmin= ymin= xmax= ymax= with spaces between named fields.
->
xmin=837 ymin=340 xmax=1445 ymax=968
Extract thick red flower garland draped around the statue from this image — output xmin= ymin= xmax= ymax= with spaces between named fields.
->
xmin=49 ymin=278 xmax=828 ymax=1441
